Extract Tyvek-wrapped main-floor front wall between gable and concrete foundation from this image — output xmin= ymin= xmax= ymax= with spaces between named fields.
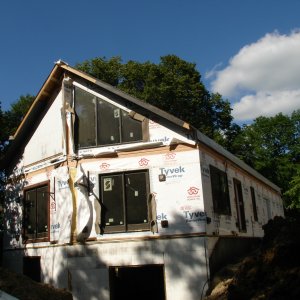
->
xmin=2 ymin=147 xmax=206 ymax=247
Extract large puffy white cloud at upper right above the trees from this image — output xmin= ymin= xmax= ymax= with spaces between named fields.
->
xmin=210 ymin=31 xmax=300 ymax=121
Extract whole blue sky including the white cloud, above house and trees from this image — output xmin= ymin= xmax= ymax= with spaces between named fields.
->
xmin=0 ymin=0 xmax=300 ymax=122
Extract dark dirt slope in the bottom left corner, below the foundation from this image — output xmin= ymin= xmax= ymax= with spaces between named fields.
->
xmin=0 ymin=268 xmax=73 ymax=300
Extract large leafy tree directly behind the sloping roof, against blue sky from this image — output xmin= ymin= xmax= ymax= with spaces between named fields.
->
xmin=76 ymin=55 xmax=232 ymax=138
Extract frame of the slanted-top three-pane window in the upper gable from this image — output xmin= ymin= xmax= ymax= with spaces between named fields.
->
xmin=73 ymin=84 xmax=149 ymax=150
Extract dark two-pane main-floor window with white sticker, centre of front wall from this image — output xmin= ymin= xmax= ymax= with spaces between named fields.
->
xmin=100 ymin=171 xmax=150 ymax=232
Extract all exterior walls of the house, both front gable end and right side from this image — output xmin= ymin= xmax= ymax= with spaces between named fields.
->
xmin=3 ymin=73 xmax=283 ymax=300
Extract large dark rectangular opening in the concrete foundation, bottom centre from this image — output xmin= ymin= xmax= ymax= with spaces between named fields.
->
xmin=109 ymin=265 xmax=165 ymax=300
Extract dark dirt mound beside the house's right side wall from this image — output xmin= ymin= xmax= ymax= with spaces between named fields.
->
xmin=206 ymin=215 xmax=300 ymax=300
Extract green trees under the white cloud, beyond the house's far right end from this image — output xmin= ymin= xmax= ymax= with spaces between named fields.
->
xmin=232 ymin=110 xmax=300 ymax=207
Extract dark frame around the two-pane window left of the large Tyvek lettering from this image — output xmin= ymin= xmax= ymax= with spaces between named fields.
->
xmin=99 ymin=169 xmax=152 ymax=233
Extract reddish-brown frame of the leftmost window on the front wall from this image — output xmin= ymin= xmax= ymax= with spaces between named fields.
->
xmin=22 ymin=180 xmax=50 ymax=243
